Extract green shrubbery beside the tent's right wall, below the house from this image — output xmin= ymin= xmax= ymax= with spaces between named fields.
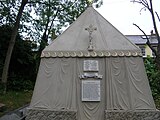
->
xmin=144 ymin=58 xmax=160 ymax=101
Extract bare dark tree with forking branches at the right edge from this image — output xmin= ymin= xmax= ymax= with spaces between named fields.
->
xmin=132 ymin=0 xmax=160 ymax=69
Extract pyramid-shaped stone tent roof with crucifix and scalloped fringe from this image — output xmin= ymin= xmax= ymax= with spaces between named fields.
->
xmin=41 ymin=7 xmax=141 ymax=57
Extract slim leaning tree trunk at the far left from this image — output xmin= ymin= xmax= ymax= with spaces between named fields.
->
xmin=2 ymin=0 xmax=28 ymax=94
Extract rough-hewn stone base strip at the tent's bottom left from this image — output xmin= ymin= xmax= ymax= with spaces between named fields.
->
xmin=25 ymin=109 xmax=77 ymax=120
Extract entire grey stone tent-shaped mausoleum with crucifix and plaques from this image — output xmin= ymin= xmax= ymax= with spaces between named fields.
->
xmin=26 ymin=7 xmax=160 ymax=120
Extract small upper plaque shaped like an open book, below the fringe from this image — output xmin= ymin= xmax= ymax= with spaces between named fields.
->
xmin=83 ymin=60 xmax=98 ymax=71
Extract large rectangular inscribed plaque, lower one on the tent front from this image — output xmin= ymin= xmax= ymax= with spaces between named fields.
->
xmin=82 ymin=80 xmax=100 ymax=101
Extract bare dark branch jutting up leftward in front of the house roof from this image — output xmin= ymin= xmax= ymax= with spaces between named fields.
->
xmin=133 ymin=23 xmax=157 ymax=56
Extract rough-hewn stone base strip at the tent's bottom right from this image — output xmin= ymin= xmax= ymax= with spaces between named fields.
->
xmin=105 ymin=110 xmax=160 ymax=120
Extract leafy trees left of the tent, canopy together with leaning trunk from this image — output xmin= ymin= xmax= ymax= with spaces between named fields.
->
xmin=0 ymin=0 xmax=101 ymax=93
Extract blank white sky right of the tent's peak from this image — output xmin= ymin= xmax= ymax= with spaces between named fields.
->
xmin=93 ymin=0 xmax=160 ymax=35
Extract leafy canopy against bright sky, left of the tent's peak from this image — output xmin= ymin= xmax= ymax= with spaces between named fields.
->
xmin=0 ymin=0 xmax=103 ymax=42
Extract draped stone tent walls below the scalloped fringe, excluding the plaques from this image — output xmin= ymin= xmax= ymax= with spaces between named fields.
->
xmin=30 ymin=57 xmax=155 ymax=120
